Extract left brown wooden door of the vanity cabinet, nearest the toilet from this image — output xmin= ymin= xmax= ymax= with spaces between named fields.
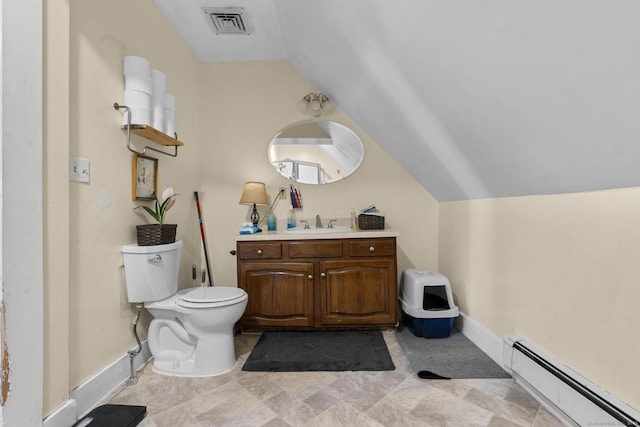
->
xmin=238 ymin=262 xmax=314 ymax=327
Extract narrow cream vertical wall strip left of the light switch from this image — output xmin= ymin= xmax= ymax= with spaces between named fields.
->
xmin=42 ymin=0 xmax=71 ymax=418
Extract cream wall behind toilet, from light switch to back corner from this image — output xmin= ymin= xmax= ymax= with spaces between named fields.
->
xmin=65 ymin=1 xmax=201 ymax=387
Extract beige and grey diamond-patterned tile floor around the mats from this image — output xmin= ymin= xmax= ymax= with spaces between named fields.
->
xmin=108 ymin=331 xmax=564 ymax=427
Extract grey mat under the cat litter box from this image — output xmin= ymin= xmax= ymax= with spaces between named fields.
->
xmin=396 ymin=325 xmax=510 ymax=379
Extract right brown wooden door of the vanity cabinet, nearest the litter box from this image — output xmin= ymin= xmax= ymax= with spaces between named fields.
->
xmin=318 ymin=258 xmax=397 ymax=326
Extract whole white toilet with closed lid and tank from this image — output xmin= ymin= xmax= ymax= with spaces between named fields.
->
xmin=122 ymin=241 xmax=248 ymax=377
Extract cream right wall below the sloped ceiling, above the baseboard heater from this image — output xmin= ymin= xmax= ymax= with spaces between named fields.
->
xmin=440 ymin=188 xmax=640 ymax=408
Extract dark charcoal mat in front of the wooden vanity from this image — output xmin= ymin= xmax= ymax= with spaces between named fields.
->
xmin=242 ymin=331 xmax=395 ymax=372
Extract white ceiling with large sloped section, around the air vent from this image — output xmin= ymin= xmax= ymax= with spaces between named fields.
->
xmin=154 ymin=0 xmax=640 ymax=201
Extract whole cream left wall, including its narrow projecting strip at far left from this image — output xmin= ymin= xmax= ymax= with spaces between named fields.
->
xmin=38 ymin=0 xmax=201 ymax=416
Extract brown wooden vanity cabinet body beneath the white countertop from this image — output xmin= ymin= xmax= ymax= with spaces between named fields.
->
xmin=237 ymin=237 xmax=397 ymax=329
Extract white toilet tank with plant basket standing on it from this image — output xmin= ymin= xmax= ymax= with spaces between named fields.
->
xmin=122 ymin=240 xmax=182 ymax=302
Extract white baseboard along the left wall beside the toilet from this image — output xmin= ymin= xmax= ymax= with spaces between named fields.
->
xmin=42 ymin=340 xmax=151 ymax=427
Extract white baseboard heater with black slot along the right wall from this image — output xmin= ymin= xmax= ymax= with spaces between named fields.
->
xmin=503 ymin=335 xmax=640 ymax=427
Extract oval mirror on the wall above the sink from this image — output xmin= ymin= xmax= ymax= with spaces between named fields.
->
xmin=269 ymin=121 xmax=364 ymax=184
